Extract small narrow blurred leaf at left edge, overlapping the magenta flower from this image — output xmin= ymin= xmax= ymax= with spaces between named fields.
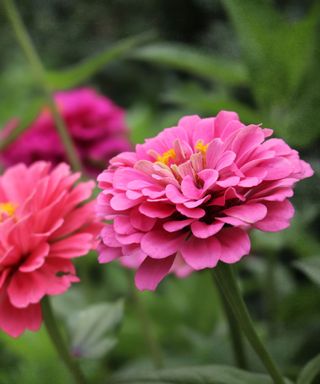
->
xmin=0 ymin=98 xmax=45 ymax=151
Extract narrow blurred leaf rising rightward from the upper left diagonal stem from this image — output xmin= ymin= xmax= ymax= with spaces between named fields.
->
xmin=47 ymin=33 xmax=154 ymax=89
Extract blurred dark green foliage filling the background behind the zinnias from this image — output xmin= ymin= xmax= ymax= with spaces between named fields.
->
xmin=0 ymin=0 xmax=320 ymax=384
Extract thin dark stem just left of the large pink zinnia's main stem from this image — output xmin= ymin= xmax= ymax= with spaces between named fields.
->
xmin=216 ymin=283 xmax=248 ymax=370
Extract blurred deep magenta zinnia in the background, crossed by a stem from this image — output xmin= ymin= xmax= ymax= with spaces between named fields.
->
xmin=0 ymin=88 xmax=130 ymax=175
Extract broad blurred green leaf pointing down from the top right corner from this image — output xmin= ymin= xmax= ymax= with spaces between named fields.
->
xmin=223 ymin=0 xmax=320 ymax=109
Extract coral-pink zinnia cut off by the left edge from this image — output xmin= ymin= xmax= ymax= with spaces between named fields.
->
xmin=0 ymin=162 xmax=101 ymax=337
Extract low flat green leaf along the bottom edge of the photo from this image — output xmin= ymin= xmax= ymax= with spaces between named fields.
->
xmin=110 ymin=365 xmax=290 ymax=384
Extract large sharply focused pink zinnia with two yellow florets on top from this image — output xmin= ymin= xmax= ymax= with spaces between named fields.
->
xmin=98 ymin=111 xmax=313 ymax=290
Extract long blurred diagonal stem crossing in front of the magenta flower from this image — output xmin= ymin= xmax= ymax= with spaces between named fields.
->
xmin=3 ymin=0 xmax=81 ymax=171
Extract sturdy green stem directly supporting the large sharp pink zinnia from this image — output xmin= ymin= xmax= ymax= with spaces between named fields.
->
xmin=212 ymin=263 xmax=285 ymax=384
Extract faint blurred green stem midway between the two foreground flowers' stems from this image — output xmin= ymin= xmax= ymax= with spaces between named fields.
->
xmin=127 ymin=271 xmax=164 ymax=369
